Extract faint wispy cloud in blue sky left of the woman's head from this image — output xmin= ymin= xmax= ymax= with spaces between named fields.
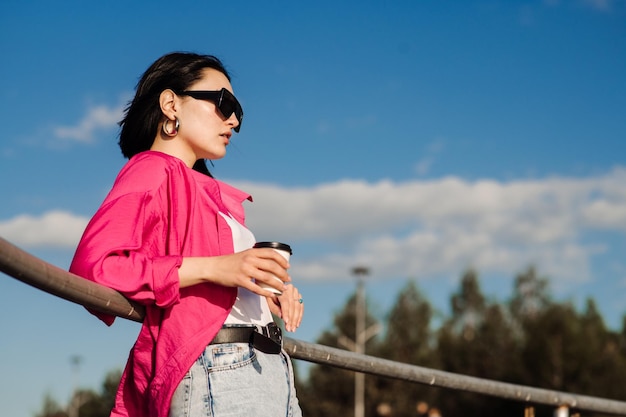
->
xmin=53 ymin=105 xmax=124 ymax=143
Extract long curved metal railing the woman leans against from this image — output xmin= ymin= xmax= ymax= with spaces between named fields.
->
xmin=0 ymin=238 xmax=626 ymax=416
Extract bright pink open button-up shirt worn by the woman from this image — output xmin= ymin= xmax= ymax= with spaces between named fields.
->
xmin=70 ymin=151 xmax=251 ymax=417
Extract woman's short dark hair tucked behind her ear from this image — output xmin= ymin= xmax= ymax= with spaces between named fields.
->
xmin=119 ymin=52 xmax=230 ymax=163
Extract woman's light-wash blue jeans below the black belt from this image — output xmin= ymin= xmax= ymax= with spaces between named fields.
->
xmin=169 ymin=343 xmax=302 ymax=417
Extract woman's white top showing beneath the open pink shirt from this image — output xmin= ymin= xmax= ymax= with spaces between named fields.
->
xmin=220 ymin=212 xmax=274 ymax=326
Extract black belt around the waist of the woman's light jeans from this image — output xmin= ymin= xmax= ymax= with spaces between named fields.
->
xmin=209 ymin=323 xmax=283 ymax=353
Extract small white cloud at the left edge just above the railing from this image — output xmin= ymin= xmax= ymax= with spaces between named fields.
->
xmin=0 ymin=211 xmax=89 ymax=248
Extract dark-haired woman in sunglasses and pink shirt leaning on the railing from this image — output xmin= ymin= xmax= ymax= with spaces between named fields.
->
xmin=70 ymin=53 xmax=303 ymax=417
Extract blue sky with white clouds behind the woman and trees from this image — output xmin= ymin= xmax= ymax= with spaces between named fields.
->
xmin=0 ymin=0 xmax=626 ymax=417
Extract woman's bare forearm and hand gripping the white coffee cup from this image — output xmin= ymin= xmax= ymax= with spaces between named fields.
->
xmin=178 ymin=248 xmax=291 ymax=297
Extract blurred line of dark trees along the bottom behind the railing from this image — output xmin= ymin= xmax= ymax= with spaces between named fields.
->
xmin=35 ymin=267 xmax=626 ymax=417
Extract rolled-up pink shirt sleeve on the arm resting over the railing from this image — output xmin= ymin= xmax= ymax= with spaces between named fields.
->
xmin=70 ymin=189 xmax=182 ymax=325
